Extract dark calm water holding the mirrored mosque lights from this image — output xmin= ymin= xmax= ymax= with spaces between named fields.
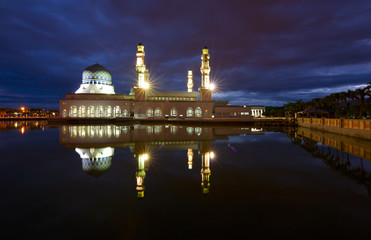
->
xmin=0 ymin=122 xmax=371 ymax=239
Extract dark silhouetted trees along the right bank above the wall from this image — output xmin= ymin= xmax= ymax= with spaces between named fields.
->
xmin=264 ymin=81 xmax=371 ymax=118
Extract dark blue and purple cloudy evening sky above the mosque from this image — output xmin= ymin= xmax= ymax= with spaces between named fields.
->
xmin=0 ymin=0 xmax=371 ymax=108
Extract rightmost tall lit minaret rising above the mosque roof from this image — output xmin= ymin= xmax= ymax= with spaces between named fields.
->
xmin=199 ymin=47 xmax=211 ymax=101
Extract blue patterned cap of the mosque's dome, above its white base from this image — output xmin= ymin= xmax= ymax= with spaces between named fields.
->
xmin=82 ymin=63 xmax=112 ymax=85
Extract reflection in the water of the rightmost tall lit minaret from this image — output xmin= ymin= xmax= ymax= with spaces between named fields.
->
xmin=200 ymin=141 xmax=214 ymax=194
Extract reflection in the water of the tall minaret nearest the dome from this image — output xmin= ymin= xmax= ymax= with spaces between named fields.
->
xmin=134 ymin=143 xmax=150 ymax=198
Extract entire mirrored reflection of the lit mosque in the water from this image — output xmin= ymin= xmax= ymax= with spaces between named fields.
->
xmin=59 ymin=125 xmax=264 ymax=198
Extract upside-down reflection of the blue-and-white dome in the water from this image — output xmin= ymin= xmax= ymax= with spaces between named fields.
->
xmin=75 ymin=147 xmax=115 ymax=177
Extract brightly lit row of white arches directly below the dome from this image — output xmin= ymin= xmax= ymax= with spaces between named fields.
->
xmin=66 ymin=105 xmax=130 ymax=117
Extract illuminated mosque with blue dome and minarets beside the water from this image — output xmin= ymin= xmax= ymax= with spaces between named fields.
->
xmin=59 ymin=43 xmax=265 ymax=120
